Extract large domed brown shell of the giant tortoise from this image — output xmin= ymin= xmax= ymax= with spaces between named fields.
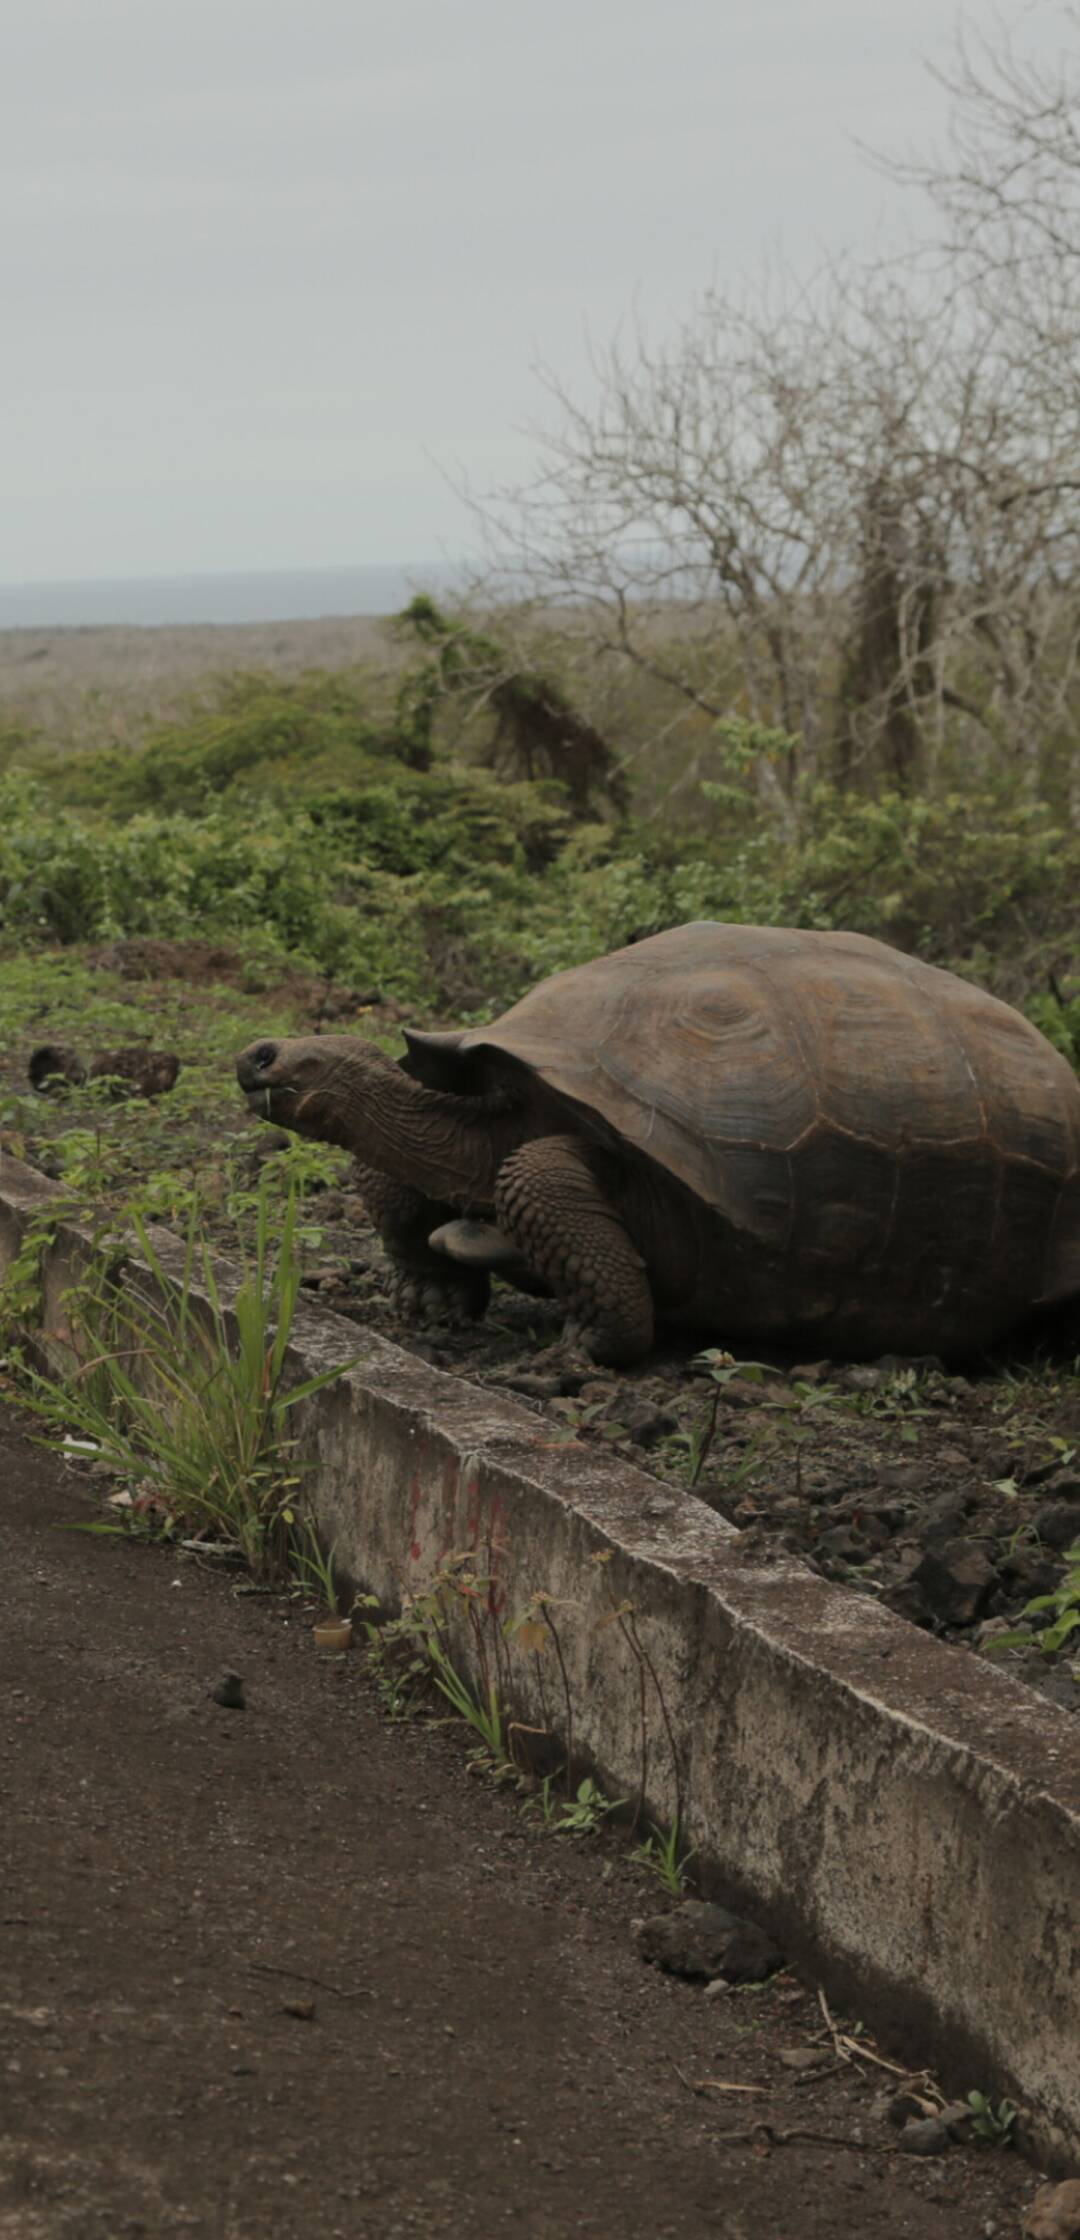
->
xmin=406 ymin=923 xmax=1080 ymax=1351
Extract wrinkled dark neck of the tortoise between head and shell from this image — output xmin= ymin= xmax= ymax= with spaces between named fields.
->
xmin=289 ymin=1044 xmax=522 ymax=1210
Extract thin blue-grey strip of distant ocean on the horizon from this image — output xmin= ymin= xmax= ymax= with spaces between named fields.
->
xmin=0 ymin=562 xmax=453 ymax=629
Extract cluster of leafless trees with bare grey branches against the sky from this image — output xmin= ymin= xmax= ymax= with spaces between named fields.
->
xmin=463 ymin=18 xmax=1080 ymax=806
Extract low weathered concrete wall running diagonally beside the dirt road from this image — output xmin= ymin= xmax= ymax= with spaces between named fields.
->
xmin=0 ymin=1154 xmax=1080 ymax=2168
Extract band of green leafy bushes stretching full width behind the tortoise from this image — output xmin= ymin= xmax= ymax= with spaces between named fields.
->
xmin=0 ymin=672 xmax=1080 ymax=1062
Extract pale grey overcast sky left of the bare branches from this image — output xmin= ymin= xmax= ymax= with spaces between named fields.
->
xmin=0 ymin=0 xmax=1060 ymax=582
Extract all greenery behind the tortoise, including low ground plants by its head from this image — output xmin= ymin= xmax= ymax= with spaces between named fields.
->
xmin=0 ymin=631 xmax=1080 ymax=1308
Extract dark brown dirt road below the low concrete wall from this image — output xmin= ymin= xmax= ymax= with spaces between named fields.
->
xmin=0 ymin=1406 xmax=1044 ymax=2240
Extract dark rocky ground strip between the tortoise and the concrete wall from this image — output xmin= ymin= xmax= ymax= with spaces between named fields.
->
xmin=291 ymin=1192 xmax=1080 ymax=1709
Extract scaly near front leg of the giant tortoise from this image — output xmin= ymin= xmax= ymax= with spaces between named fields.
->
xmin=495 ymin=1136 xmax=652 ymax=1366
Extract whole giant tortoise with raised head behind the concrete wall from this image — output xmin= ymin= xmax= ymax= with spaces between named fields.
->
xmin=238 ymin=923 xmax=1080 ymax=1362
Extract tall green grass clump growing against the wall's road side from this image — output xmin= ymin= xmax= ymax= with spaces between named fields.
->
xmin=22 ymin=1194 xmax=350 ymax=1577
